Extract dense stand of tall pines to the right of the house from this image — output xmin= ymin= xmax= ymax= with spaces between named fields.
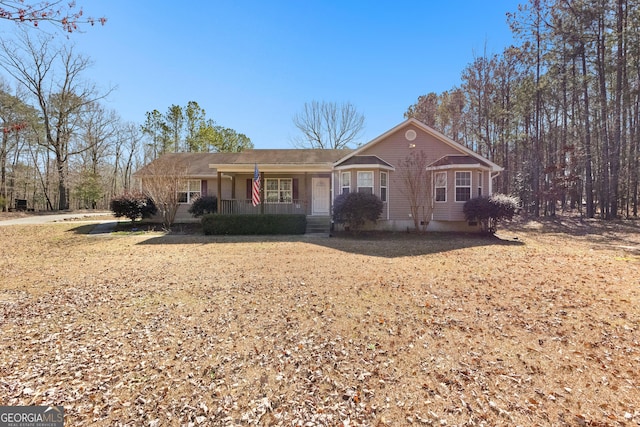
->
xmin=405 ymin=0 xmax=640 ymax=219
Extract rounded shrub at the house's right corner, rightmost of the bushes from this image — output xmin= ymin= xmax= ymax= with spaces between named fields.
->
xmin=462 ymin=194 xmax=519 ymax=234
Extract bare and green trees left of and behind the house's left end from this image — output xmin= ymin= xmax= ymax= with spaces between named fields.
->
xmin=0 ymin=31 xmax=252 ymax=211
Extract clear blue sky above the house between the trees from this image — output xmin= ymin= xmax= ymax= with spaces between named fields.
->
xmin=70 ymin=0 xmax=519 ymax=148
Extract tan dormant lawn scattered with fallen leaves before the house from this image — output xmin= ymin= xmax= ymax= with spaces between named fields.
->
xmin=0 ymin=222 xmax=640 ymax=426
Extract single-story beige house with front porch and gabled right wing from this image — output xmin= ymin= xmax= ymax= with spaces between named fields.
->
xmin=134 ymin=119 xmax=503 ymax=231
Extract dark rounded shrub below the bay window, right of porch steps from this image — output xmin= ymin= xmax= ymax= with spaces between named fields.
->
xmin=333 ymin=192 xmax=384 ymax=231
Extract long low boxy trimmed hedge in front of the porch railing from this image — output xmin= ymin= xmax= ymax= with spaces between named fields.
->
xmin=201 ymin=214 xmax=307 ymax=235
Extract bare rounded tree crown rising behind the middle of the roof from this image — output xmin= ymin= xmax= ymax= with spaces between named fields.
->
xmin=293 ymin=101 xmax=364 ymax=149
